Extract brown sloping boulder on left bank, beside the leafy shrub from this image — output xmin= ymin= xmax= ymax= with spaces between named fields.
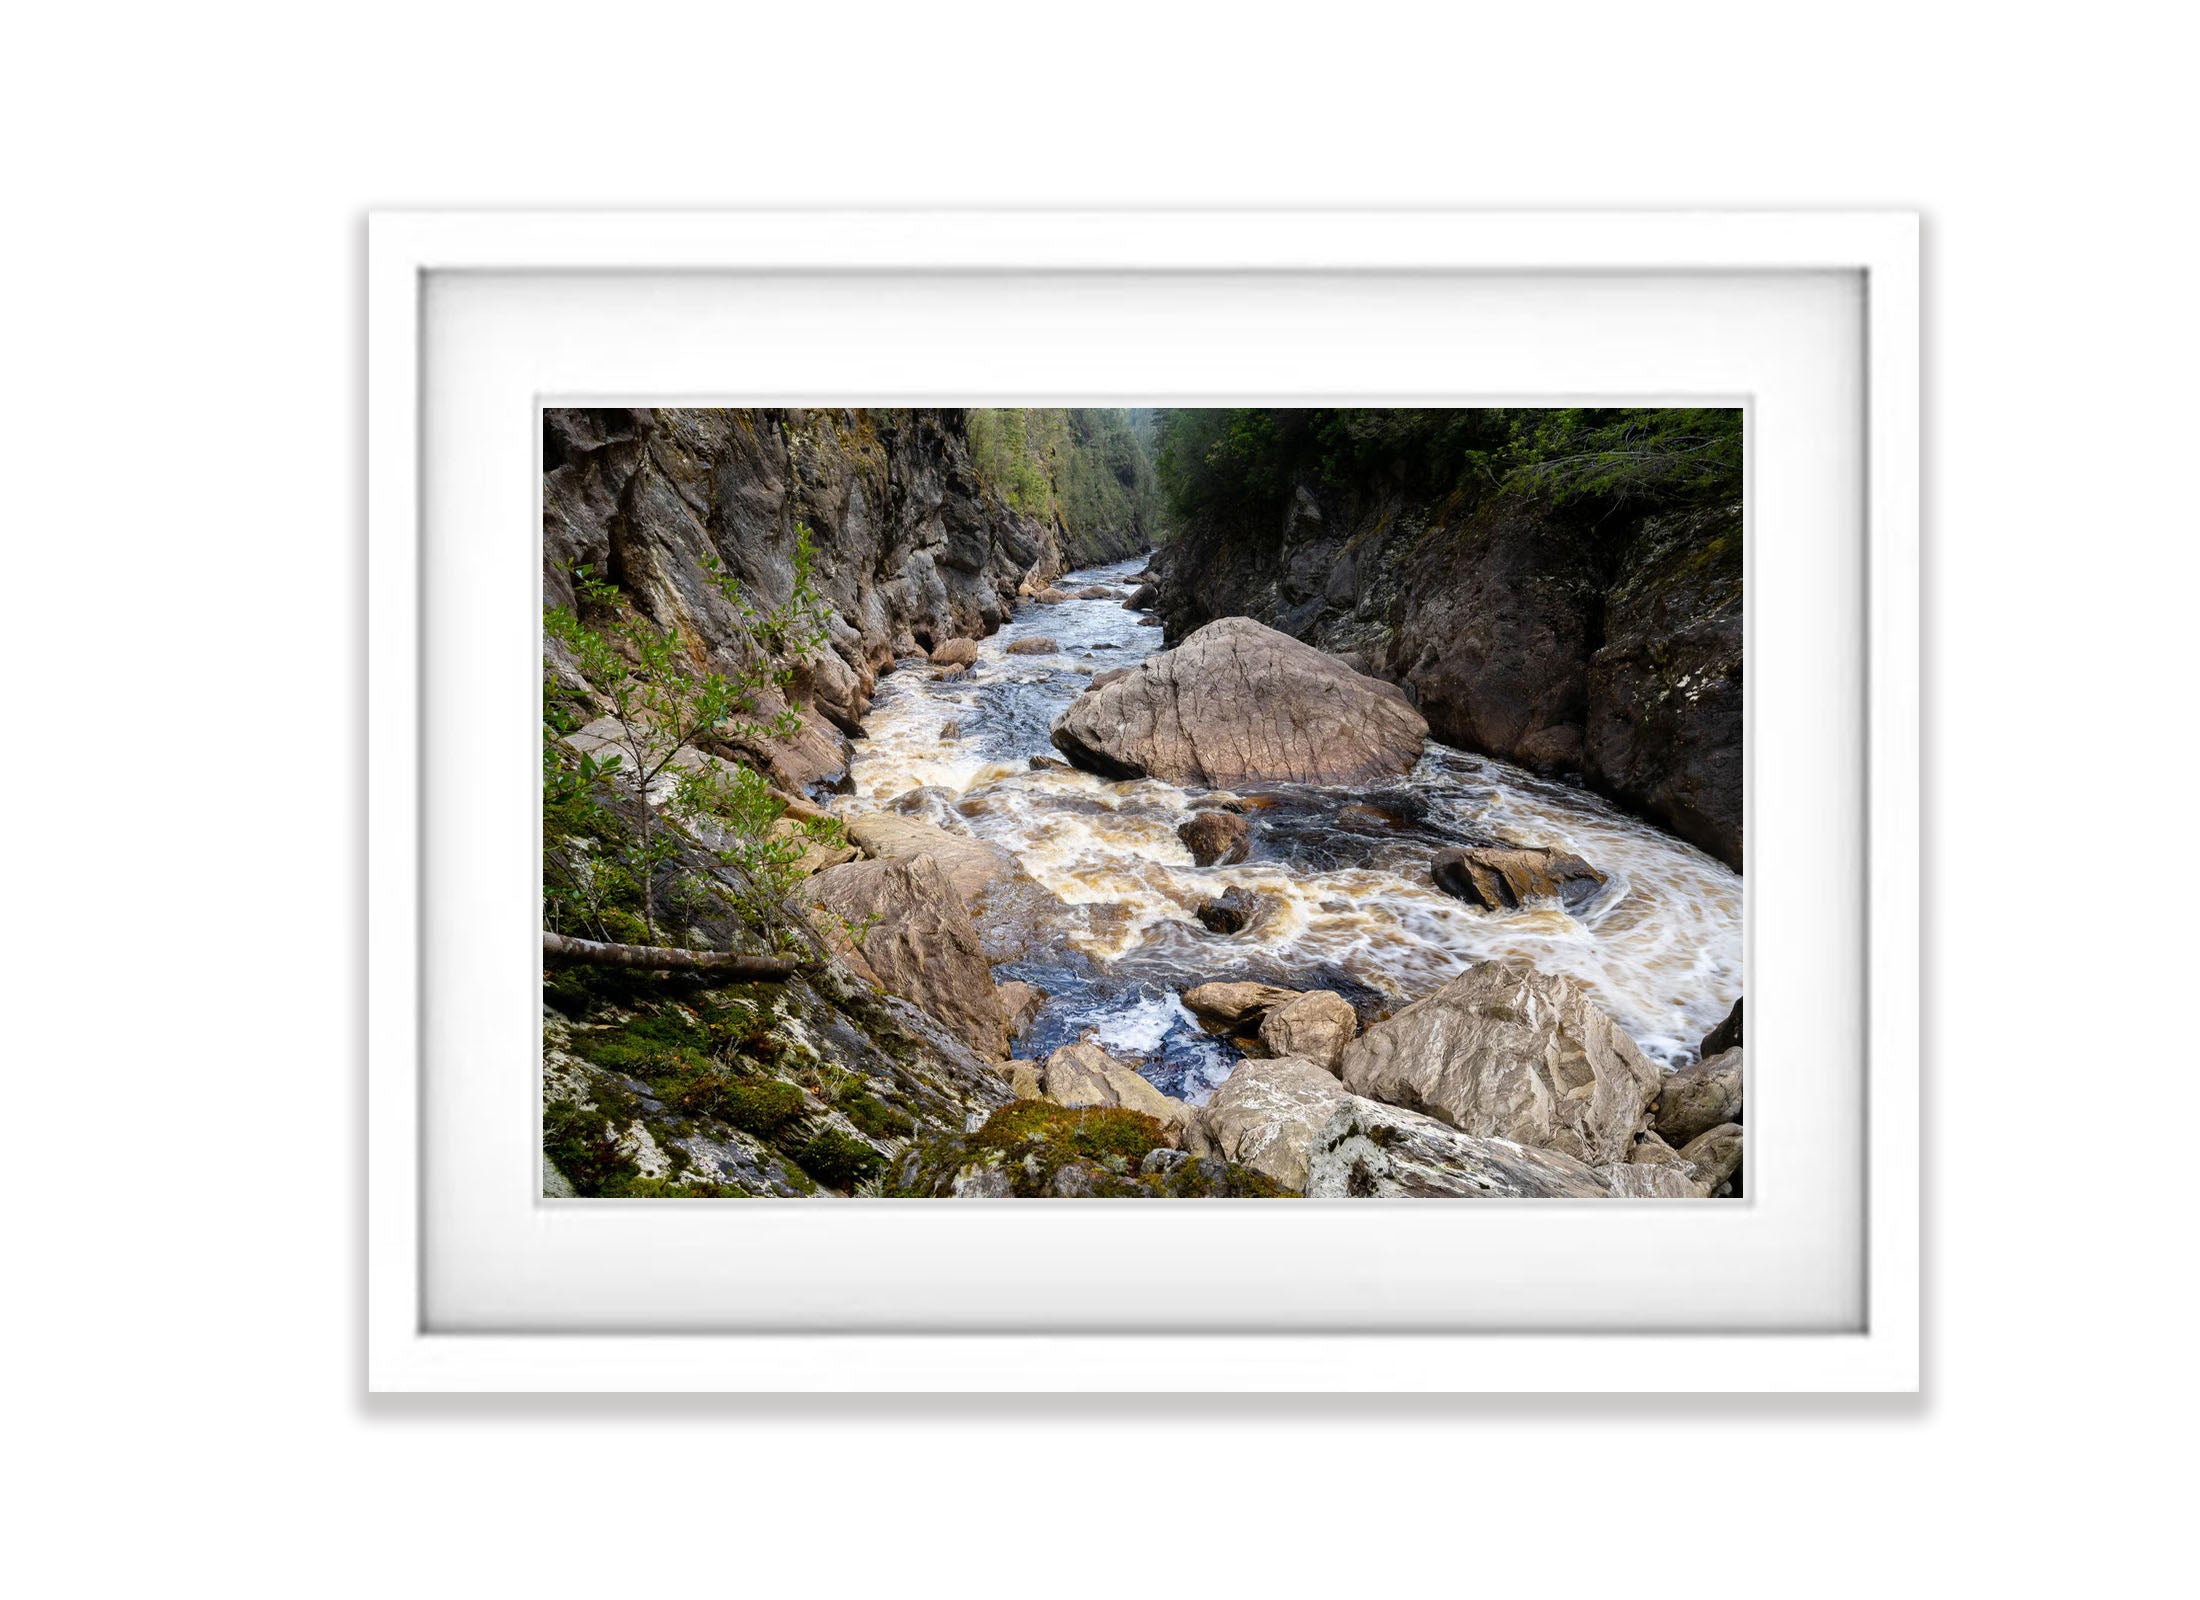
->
xmin=803 ymin=856 xmax=1008 ymax=1061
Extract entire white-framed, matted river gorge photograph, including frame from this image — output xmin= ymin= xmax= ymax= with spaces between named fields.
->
xmin=367 ymin=211 xmax=1918 ymax=1391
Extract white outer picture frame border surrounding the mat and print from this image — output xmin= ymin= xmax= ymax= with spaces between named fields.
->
xmin=367 ymin=211 xmax=1921 ymax=1391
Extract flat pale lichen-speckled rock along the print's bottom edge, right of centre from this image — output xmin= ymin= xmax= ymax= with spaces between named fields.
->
xmin=1293 ymin=1100 xmax=1610 ymax=1199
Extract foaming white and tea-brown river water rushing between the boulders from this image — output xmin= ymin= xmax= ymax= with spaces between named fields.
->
xmin=834 ymin=559 xmax=1742 ymax=1103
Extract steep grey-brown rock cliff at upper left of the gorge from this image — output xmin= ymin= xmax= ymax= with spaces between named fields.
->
xmin=543 ymin=409 xmax=1065 ymax=788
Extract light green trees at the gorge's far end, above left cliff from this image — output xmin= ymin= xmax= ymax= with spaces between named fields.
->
xmin=970 ymin=407 xmax=1162 ymax=561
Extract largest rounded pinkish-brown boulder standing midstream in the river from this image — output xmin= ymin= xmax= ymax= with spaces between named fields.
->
xmin=1054 ymin=616 xmax=1428 ymax=788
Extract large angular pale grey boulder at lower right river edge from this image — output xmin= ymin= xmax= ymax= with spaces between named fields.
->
xmin=1344 ymin=962 xmax=1661 ymax=1166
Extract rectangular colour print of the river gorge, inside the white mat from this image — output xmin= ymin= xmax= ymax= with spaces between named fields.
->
xmin=541 ymin=407 xmax=1745 ymax=1202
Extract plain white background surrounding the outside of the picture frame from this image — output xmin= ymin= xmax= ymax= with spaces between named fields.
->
xmin=0 ymin=0 xmax=2196 ymax=1596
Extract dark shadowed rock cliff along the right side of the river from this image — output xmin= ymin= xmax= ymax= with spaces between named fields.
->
xmin=1155 ymin=480 xmax=1742 ymax=869
